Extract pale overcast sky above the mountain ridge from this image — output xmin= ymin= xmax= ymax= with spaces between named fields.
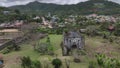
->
xmin=0 ymin=0 xmax=120 ymax=7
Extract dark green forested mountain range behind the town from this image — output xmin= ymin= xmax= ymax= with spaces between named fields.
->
xmin=9 ymin=0 xmax=120 ymax=15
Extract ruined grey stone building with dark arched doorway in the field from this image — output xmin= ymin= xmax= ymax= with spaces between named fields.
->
xmin=61 ymin=31 xmax=85 ymax=56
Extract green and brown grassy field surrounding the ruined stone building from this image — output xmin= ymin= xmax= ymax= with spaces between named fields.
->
xmin=0 ymin=35 xmax=120 ymax=68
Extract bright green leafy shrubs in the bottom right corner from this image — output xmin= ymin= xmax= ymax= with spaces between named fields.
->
xmin=96 ymin=54 xmax=120 ymax=68
